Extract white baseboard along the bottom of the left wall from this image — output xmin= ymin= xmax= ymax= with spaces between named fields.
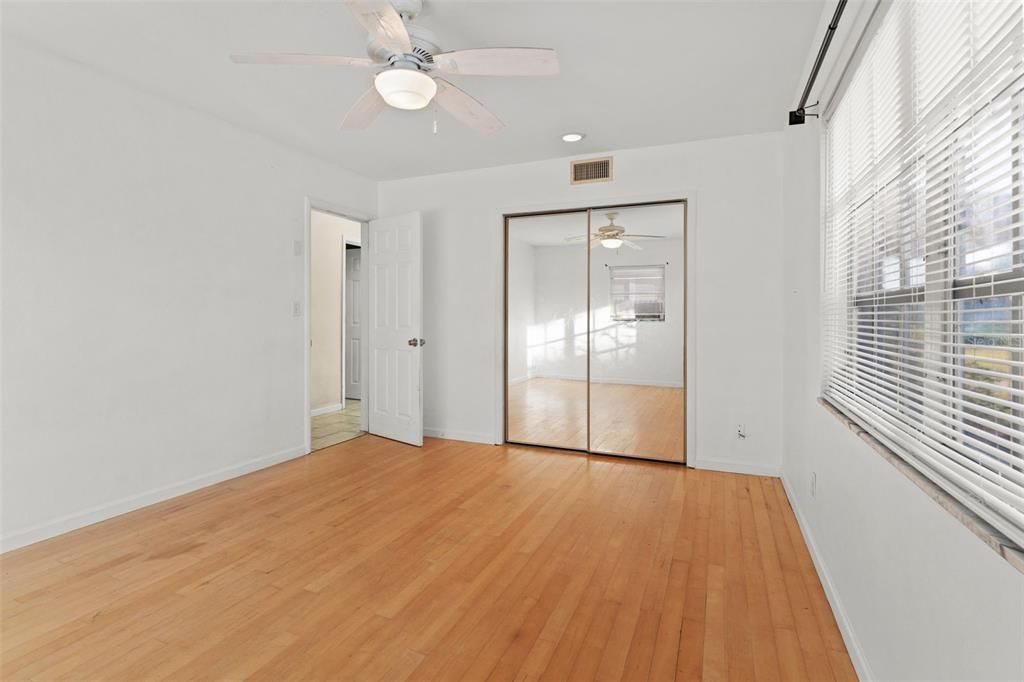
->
xmin=0 ymin=446 xmax=306 ymax=552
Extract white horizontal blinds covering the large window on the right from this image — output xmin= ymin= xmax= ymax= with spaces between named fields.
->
xmin=823 ymin=0 xmax=1024 ymax=546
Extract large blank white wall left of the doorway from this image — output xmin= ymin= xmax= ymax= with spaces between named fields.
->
xmin=0 ymin=35 xmax=376 ymax=548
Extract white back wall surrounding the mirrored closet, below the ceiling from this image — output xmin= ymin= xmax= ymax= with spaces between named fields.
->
xmin=378 ymin=133 xmax=782 ymax=472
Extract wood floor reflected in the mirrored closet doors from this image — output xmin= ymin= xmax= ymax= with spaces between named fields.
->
xmin=508 ymin=378 xmax=686 ymax=462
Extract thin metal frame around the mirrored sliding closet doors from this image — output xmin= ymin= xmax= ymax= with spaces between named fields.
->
xmin=501 ymin=199 xmax=695 ymax=466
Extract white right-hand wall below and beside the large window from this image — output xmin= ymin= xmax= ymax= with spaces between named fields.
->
xmin=782 ymin=123 xmax=1024 ymax=680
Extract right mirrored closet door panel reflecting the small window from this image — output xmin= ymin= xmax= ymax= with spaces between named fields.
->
xmin=590 ymin=199 xmax=686 ymax=462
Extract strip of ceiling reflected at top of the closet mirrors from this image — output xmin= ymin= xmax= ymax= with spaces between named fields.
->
xmin=509 ymin=204 xmax=683 ymax=248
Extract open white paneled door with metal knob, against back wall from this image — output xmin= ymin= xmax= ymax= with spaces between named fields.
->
xmin=362 ymin=213 xmax=424 ymax=445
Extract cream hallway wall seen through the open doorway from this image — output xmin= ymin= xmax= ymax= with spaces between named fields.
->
xmin=309 ymin=211 xmax=362 ymax=414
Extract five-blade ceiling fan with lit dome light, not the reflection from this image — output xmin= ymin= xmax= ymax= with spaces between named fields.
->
xmin=231 ymin=0 xmax=558 ymax=135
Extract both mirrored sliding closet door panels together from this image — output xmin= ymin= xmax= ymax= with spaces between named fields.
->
xmin=505 ymin=200 xmax=686 ymax=463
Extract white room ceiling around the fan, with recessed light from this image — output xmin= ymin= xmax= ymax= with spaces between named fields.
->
xmin=3 ymin=0 xmax=822 ymax=179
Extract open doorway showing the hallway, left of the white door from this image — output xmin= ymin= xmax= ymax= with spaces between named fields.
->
xmin=309 ymin=208 xmax=365 ymax=451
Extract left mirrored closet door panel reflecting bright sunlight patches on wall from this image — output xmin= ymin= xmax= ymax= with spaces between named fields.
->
xmin=505 ymin=211 xmax=589 ymax=450
